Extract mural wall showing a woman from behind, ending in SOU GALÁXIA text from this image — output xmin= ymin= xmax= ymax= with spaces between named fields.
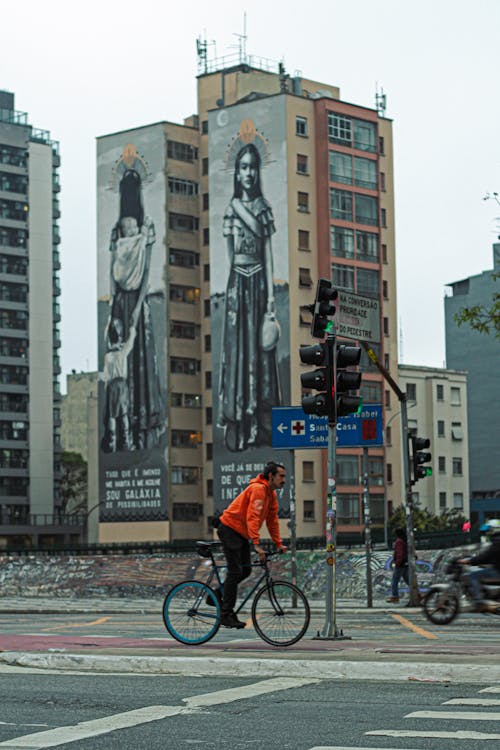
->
xmin=97 ymin=126 xmax=168 ymax=521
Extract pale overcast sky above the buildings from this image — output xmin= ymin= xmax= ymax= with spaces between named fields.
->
xmin=0 ymin=0 xmax=500 ymax=390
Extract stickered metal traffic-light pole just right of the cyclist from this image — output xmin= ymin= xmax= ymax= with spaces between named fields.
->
xmin=316 ymin=331 xmax=350 ymax=640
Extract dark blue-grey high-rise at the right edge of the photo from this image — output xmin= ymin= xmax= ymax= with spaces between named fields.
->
xmin=444 ymin=243 xmax=500 ymax=517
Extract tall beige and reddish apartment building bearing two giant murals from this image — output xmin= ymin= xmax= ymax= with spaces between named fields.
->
xmin=98 ymin=56 xmax=399 ymax=540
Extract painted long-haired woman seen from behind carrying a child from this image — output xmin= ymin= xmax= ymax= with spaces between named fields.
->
xmin=103 ymin=169 xmax=162 ymax=451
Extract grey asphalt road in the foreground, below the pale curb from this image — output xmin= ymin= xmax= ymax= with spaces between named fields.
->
xmin=0 ymin=666 xmax=500 ymax=750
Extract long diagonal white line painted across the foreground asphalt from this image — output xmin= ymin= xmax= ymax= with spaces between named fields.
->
xmin=0 ymin=677 xmax=319 ymax=750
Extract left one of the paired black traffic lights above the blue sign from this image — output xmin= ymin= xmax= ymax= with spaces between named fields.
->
xmin=300 ymin=337 xmax=335 ymax=421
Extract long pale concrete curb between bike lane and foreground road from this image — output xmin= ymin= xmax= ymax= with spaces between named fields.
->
xmin=0 ymin=651 xmax=500 ymax=684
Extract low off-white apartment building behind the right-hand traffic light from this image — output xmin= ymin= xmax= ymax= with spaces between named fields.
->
xmin=394 ymin=365 xmax=470 ymax=518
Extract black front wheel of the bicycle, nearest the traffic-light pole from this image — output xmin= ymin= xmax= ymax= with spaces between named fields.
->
xmin=252 ymin=581 xmax=311 ymax=646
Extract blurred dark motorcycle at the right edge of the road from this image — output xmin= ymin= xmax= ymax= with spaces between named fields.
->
xmin=422 ymin=559 xmax=500 ymax=625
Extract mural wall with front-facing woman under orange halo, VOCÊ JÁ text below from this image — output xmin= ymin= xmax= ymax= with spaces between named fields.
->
xmin=208 ymin=96 xmax=291 ymax=512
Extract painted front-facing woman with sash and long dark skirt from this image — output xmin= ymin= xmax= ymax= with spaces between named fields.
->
xmin=218 ymin=143 xmax=281 ymax=451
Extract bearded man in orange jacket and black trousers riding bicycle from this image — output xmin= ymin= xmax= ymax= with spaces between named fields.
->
xmin=213 ymin=461 xmax=287 ymax=628
